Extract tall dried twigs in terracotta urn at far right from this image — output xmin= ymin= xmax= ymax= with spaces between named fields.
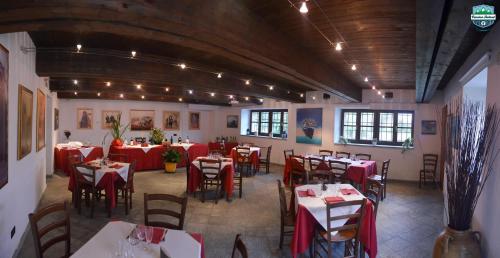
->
xmin=433 ymin=100 xmax=500 ymax=258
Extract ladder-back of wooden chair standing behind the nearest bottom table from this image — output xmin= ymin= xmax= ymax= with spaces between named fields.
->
xmin=144 ymin=193 xmax=187 ymax=230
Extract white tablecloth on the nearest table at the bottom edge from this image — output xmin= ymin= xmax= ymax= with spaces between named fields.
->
xmin=71 ymin=221 xmax=201 ymax=258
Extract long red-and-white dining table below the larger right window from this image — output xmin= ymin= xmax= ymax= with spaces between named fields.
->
xmin=283 ymin=154 xmax=377 ymax=192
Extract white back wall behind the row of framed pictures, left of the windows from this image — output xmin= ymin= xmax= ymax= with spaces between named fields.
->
xmin=58 ymin=99 xmax=218 ymax=155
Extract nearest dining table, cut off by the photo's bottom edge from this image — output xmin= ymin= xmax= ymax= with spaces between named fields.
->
xmin=71 ymin=221 xmax=205 ymax=258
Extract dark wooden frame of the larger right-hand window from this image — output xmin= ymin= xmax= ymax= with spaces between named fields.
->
xmin=340 ymin=109 xmax=415 ymax=146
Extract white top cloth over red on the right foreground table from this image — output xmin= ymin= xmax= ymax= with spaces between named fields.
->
xmin=295 ymin=184 xmax=365 ymax=234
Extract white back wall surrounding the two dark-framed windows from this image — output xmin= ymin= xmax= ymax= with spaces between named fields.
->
xmin=210 ymin=90 xmax=442 ymax=180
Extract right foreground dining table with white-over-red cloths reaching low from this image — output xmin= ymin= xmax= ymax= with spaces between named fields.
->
xmin=291 ymin=184 xmax=377 ymax=258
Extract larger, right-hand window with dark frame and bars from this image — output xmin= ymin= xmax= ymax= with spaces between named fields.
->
xmin=341 ymin=110 xmax=414 ymax=146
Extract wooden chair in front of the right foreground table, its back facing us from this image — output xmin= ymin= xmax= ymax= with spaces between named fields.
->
xmin=312 ymin=199 xmax=366 ymax=258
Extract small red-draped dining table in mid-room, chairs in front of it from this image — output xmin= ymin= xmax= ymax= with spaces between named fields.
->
xmin=188 ymin=156 xmax=234 ymax=201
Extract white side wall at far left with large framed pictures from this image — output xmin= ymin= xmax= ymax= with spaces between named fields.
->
xmin=0 ymin=33 xmax=51 ymax=258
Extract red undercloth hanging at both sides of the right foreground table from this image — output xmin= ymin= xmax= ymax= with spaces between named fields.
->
xmin=291 ymin=201 xmax=377 ymax=258
